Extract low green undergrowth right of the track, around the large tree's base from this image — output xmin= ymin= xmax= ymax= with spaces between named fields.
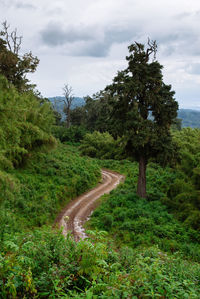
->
xmin=90 ymin=160 xmax=200 ymax=261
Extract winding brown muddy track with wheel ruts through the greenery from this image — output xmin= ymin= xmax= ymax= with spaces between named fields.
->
xmin=56 ymin=170 xmax=124 ymax=241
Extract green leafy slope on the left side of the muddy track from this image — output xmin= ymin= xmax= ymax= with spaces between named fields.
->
xmin=0 ymin=144 xmax=100 ymax=238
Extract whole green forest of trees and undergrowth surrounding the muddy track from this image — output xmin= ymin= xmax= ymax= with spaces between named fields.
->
xmin=0 ymin=24 xmax=200 ymax=299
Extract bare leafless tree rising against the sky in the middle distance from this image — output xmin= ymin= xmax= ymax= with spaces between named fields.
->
xmin=63 ymin=84 xmax=74 ymax=128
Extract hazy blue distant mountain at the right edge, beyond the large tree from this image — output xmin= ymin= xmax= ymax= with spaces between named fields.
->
xmin=178 ymin=109 xmax=200 ymax=128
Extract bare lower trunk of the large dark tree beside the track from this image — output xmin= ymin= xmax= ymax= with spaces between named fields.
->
xmin=137 ymin=155 xmax=147 ymax=198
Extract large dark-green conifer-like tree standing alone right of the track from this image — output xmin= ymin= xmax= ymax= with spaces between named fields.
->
xmin=106 ymin=40 xmax=178 ymax=197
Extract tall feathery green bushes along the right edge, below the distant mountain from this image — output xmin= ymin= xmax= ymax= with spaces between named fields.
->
xmin=165 ymin=128 xmax=200 ymax=230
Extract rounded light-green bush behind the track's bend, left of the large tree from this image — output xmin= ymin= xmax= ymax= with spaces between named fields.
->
xmin=80 ymin=131 xmax=123 ymax=159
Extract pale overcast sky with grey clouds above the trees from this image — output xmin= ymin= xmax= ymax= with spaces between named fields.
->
xmin=0 ymin=0 xmax=200 ymax=109
